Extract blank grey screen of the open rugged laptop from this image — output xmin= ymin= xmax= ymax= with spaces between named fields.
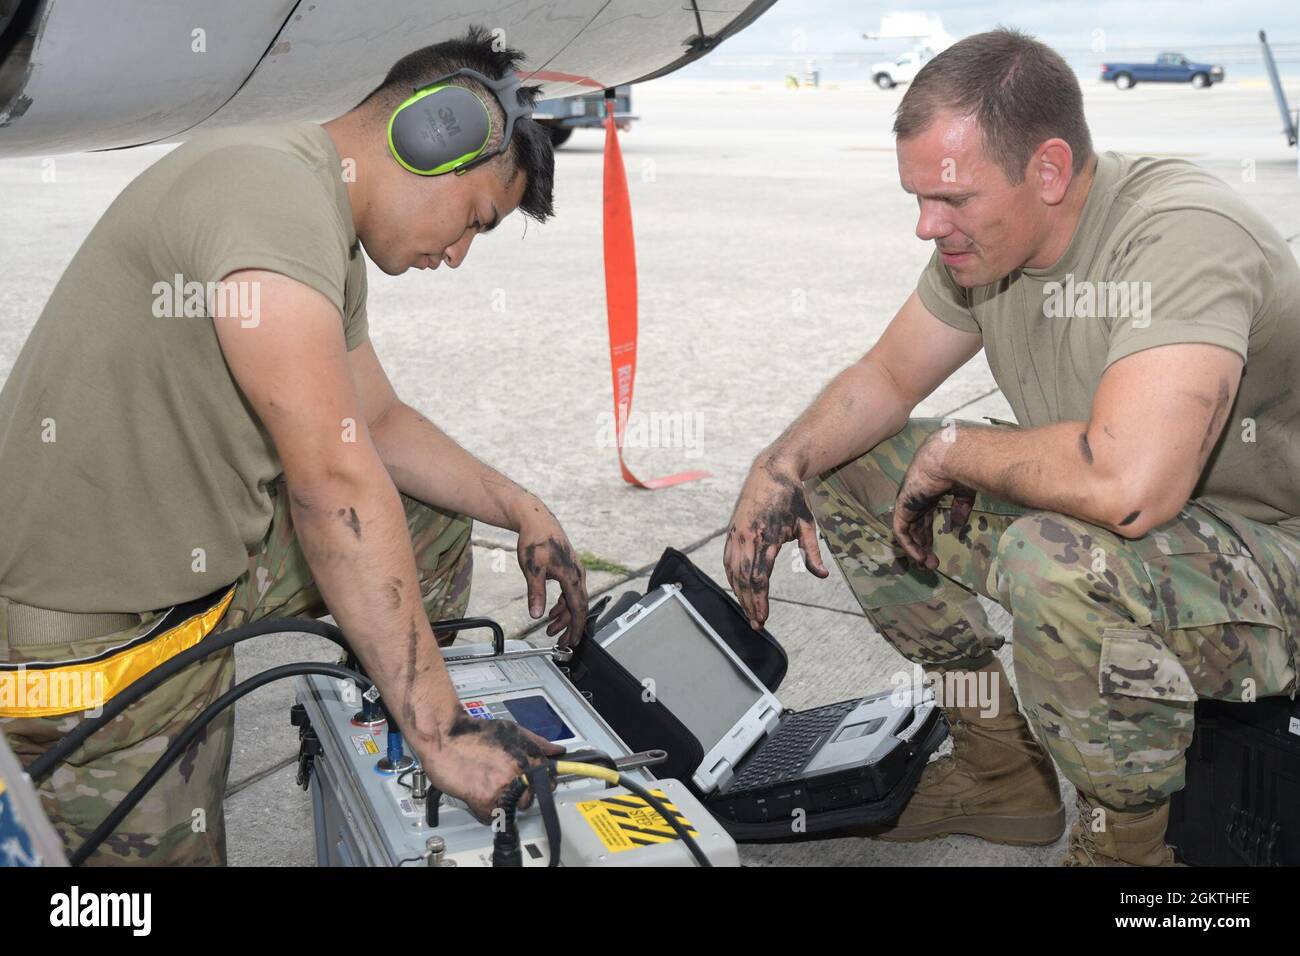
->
xmin=606 ymin=600 xmax=763 ymax=753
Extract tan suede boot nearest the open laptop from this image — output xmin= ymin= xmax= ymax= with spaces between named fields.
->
xmin=858 ymin=658 xmax=1065 ymax=845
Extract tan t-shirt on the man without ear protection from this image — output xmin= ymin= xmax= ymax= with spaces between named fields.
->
xmin=918 ymin=152 xmax=1300 ymax=531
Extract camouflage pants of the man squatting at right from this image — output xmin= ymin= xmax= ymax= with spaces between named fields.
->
xmin=806 ymin=419 xmax=1300 ymax=809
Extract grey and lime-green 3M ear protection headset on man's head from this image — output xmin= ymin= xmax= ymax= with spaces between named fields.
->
xmin=389 ymin=69 xmax=533 ymax=176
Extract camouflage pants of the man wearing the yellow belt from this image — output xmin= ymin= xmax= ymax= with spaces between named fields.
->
xmin=0 ymin=480 xmax=473 ymax=866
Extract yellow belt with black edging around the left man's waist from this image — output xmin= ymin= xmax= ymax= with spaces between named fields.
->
xmin=0 ymin=585 xmax=235 ymax=717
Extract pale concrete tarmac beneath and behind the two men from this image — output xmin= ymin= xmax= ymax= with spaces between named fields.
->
xmin=0 ymin=77 xmax=1300 ymax=865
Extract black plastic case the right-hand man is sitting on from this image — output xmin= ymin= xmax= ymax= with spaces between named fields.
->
xmin=1166 ymin=697 xmax=1300 ymax=866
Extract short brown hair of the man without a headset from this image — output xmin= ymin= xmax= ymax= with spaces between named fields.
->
xmin=893 ymin=27 xmax=1092 ymax=183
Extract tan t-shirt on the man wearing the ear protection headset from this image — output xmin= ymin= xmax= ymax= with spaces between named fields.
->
xmin=0 ymin=124 xmax=367 ymax=611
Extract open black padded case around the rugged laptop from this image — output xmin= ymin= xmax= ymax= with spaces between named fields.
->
xmin=567 ymin=548 xmax=948 ymax=843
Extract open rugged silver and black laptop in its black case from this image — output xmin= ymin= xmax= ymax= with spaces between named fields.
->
xmin=595 ymin=584 xmax=941 ymax=823
